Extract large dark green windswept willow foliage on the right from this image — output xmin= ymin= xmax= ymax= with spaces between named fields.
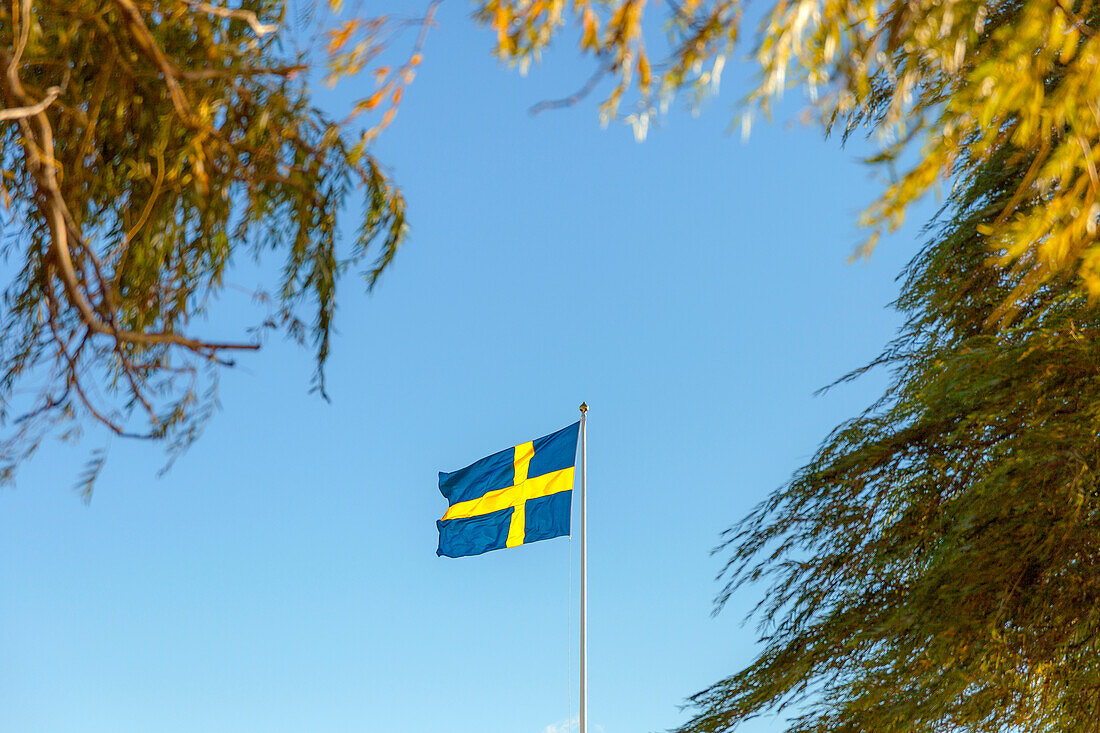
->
xmin=683 ymin=68 xmax=1100 ymax=733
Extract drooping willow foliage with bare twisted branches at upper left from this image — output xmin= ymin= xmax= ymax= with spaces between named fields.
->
xmin=0 ymin=0 xmax=405 ymax=486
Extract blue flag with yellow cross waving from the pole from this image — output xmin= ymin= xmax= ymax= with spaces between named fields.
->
xmin=436 ymin=423 xmax=581 ymax=557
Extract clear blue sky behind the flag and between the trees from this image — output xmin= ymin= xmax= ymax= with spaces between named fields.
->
xmin=0 ymin=3 xmax=917 ymax=733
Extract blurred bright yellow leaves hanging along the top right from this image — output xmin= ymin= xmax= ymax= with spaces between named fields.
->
xmin=477 ymin=0 xmax=1100 ymax=325
